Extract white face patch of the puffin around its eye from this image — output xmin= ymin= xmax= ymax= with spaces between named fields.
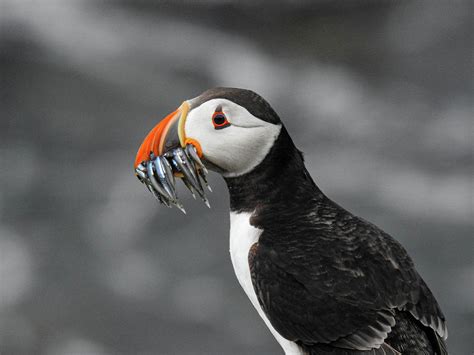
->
xmin=185 ymin=99 xmax=281 ymax=177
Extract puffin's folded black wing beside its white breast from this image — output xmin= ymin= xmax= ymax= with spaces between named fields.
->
xmin=249 ymin=221 xmax=446 ymax=350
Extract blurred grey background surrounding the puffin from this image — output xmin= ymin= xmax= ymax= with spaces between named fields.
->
xmin=0 ymin=0 xmax=474 ymax=355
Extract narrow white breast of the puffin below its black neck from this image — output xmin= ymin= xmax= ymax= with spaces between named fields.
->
xmin=230 ymin=212 xmax=303 ymax=355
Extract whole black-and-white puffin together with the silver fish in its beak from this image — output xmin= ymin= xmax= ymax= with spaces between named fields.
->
xmin=134 ymin=87 xmax=448 ymax=355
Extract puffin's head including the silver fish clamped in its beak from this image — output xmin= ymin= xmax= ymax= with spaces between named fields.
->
xmin=134 ymin=88 xmax=282 ymax=213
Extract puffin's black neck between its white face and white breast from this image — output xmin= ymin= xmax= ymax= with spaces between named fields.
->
xmin=225 ymin=127 xmax=325 ymax=222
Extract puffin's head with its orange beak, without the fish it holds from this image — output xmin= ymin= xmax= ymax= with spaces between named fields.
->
xmin=135 ymin=88 xmax=281 ymax=176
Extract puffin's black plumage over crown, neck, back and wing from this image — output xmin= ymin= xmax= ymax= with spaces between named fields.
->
xmin=220 ymin=88 xmax=447 ymax=354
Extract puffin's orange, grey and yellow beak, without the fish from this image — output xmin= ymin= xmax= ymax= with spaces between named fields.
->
xmin=134 ymin=101 xmax=194 ymax=168
